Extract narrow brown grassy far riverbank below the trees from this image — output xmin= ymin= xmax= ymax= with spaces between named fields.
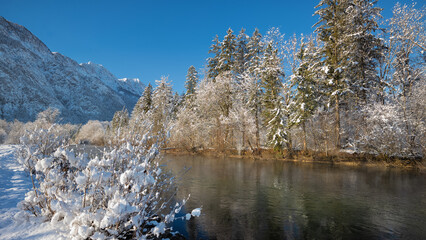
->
xmin=162 ymin=148 xmax=426 ymax=173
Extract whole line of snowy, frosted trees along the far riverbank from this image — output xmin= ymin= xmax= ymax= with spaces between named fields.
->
xmin=118 ymin=0 xmax=426 ymax=156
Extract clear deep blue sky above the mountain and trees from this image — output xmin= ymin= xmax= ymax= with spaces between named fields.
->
xmin=0 ymin=0 xmax=425 ymax=92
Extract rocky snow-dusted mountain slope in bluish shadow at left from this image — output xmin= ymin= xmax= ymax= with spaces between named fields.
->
xmin=0 ymin=17 xmax=144 ymax=123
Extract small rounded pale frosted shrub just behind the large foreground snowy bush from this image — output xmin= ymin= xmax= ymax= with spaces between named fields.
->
xmin=75 ymin=120 xmax=106 ymax=146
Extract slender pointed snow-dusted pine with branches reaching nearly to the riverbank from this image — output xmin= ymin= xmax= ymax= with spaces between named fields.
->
xmin=261 ymin=43 xmax=287 ymax=151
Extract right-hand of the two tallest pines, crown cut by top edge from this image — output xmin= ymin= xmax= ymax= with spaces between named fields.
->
xmin=343 ymin=0 xmax=385 ymax=104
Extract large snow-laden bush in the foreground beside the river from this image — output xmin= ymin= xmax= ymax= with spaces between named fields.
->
xmin=19 ymin=127 xmax=200 ymax=239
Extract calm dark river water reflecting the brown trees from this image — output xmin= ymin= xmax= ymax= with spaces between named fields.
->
xmin=164 ymin=155 xmax=426 ymax=239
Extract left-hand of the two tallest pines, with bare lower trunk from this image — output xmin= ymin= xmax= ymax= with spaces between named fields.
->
xmin=314 ymin=0 xmax=350 ymax=149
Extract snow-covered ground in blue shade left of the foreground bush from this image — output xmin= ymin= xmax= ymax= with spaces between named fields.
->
xmin=0 ymin=145 xmax=67 ymax=240
